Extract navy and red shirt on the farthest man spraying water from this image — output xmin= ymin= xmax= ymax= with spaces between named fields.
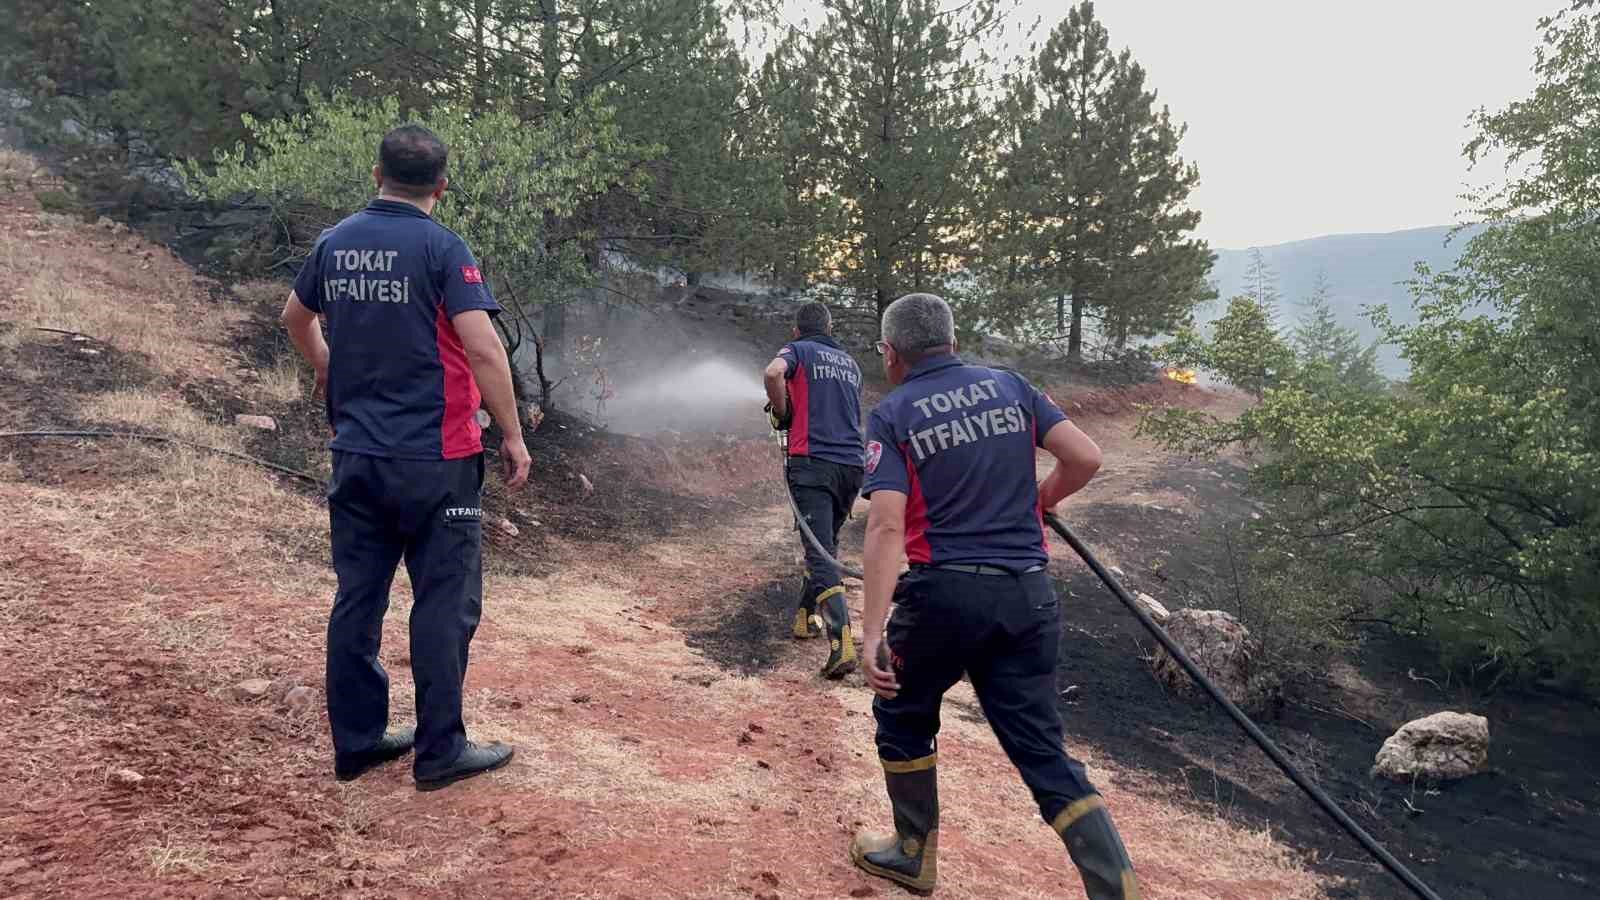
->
xmin=778 ymin=335 xmax=862 ymax=468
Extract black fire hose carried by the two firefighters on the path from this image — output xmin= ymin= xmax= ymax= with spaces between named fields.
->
xmin=776 ymin=419 xmax=1440 ymax=900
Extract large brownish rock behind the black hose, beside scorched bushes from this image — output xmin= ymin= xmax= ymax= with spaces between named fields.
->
xmin=1154 ymin=609 xmax=1278 ymax=709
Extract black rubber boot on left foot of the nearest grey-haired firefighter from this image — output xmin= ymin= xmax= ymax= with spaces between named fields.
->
xmin=850 ymin=754 xmax=939 ymax=894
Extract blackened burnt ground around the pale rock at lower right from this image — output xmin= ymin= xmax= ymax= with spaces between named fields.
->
xmin=1058 ymin=468 xmax=1600 ymax=900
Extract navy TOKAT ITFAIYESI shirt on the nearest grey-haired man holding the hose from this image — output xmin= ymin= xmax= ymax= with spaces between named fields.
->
xmin=862 ymin=354 xmax=1067 ymax=560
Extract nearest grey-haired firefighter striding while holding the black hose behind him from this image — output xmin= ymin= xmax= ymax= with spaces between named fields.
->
xmin=850 ymin=293 xmax=1139 ymax=900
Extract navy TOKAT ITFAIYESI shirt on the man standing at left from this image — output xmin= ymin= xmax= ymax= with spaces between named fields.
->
xmin=294 ymin=200 xmax=499 ymax=460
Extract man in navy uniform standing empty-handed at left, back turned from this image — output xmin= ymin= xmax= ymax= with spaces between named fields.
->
xmin=283 ymin=125 xmax=530 ymax=791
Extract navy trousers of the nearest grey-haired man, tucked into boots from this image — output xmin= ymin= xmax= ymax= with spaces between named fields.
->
xmin=872 ymin=567 xmax=1096 ymax=823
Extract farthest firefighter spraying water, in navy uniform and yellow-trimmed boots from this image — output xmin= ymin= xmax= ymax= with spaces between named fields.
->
xmin=765 ymin=303 xmax=862 ymax=679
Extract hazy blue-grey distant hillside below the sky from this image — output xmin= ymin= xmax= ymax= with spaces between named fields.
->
xmin=1200 ymin=226 xmax=1477 ymax=375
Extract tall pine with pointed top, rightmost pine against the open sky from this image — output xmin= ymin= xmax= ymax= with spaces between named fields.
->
xmin=992 ymin=0 xmax=1213 ymax=359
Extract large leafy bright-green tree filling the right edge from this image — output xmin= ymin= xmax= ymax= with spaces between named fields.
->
xmin=1144 ymin=3 xmax=1600 ymax=690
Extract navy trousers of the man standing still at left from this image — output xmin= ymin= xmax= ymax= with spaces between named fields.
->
xmin=328 ymin=453 xmax=483 ymax=777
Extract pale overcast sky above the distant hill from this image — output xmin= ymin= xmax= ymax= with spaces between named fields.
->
xmin=774 ymin=0 xmax=1548 ymax=250
